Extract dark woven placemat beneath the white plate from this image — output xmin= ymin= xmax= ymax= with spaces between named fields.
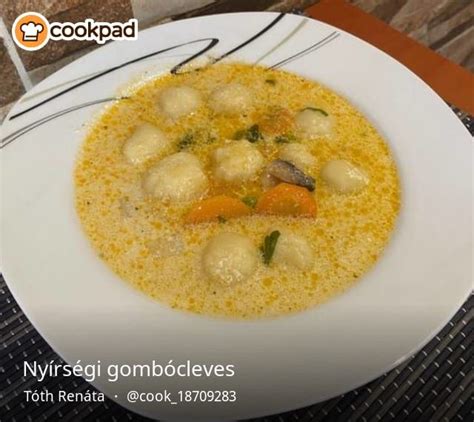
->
xmin=0 ymin=107 xmax=474 ymax=422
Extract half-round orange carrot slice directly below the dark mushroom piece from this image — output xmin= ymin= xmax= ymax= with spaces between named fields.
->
xmin=255 ymin=183 xmax=317 ymax=217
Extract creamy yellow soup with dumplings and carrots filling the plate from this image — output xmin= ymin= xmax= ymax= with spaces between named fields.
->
xmin=74 ymin=63 xmax=400 ymax=319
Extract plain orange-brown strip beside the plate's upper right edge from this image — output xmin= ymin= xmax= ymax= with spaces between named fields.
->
xmin=306 ymin=0 xmax=474 ymax=115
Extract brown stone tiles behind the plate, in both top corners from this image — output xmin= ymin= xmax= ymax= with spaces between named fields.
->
xmin=0 ymin=0 xmax=474 ymax=121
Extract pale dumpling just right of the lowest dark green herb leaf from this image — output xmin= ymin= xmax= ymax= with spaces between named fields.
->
xmin=272 ymin=230 xmax=314 ymax=270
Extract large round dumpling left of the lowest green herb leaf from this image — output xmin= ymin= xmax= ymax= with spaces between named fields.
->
xmin=202 ymin=233 xmax=259 ymax=286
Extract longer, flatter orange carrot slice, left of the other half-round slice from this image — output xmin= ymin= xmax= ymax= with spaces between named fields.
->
xmin=184 ymin=195 xmax=252 ymax=224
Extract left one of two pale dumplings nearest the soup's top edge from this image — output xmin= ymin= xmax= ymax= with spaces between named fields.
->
xmin=158 ymin=86 xmax=201 ymax=119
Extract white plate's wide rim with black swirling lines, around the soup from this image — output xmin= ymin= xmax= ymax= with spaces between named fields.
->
xmin=1 ymin=13 xmax=472 ymax=420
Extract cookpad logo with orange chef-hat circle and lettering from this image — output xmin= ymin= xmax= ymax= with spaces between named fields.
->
xmin=12 ymin=12 xmax=138 ymax=51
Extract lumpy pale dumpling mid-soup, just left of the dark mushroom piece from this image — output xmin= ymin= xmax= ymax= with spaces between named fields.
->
xmin=212 ymin=140 xmax=264 ymax=182
